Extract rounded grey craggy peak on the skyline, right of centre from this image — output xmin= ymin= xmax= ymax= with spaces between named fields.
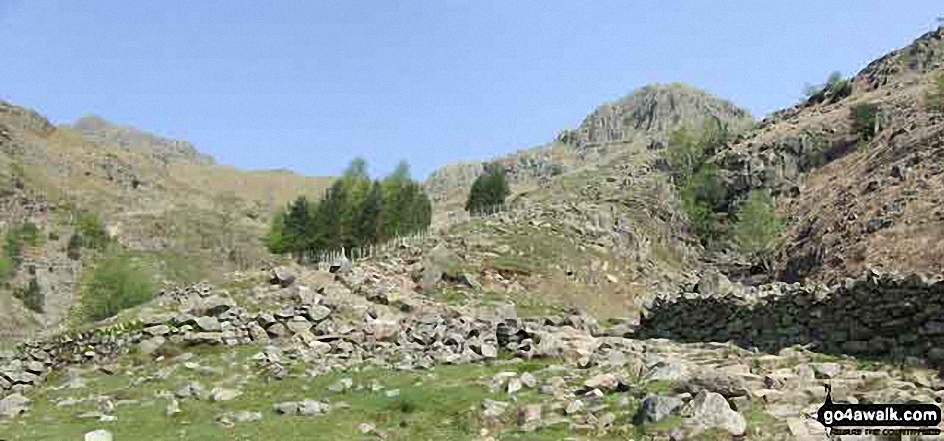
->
xmin=574 ymin=83 xmax=753 ymax=146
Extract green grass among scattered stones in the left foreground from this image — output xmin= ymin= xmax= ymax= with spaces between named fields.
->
xmin=0 ymin=346 xmax=592 ymax=441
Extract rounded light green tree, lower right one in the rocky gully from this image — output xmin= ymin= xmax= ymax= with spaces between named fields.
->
xmin=733 ymin=190 xmax=782 ymax=262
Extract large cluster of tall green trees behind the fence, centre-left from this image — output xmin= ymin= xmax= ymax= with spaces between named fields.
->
xmin=265 ymin=158 xmax=432 ymax=259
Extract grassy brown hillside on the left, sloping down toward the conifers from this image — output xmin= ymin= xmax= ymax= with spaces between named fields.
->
xmin=0 ymin=103 xmax=330 ymax=338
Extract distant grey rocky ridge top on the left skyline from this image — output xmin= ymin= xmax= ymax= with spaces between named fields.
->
xmin=72 ymin=116 xmax=213 ymax=164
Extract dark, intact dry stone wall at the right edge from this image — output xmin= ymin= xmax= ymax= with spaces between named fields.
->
xmin=636 ymin=272 xmax=944 ymax=365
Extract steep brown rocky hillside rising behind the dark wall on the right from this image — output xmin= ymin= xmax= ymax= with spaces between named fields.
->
xmin=714 ymin=29 xmax=944 ymax=282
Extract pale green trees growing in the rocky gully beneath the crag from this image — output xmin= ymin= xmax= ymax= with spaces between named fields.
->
xmin=665 ymin=118 xmax=781 ymax=262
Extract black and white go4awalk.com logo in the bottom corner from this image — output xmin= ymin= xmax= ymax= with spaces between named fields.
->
xmin=816 ymin=384 xmax=941 ymax=435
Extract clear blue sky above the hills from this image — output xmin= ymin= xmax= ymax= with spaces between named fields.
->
xmin=0 ymin=0 xmax=944 ymax=178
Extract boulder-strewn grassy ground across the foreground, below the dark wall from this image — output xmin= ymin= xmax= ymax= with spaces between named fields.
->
xmin=0 ymin=249 xmax=944 ymax=441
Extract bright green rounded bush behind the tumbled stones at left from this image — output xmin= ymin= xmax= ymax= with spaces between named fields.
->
xmin=82 ymin=254 xmax=156 ymax=321
